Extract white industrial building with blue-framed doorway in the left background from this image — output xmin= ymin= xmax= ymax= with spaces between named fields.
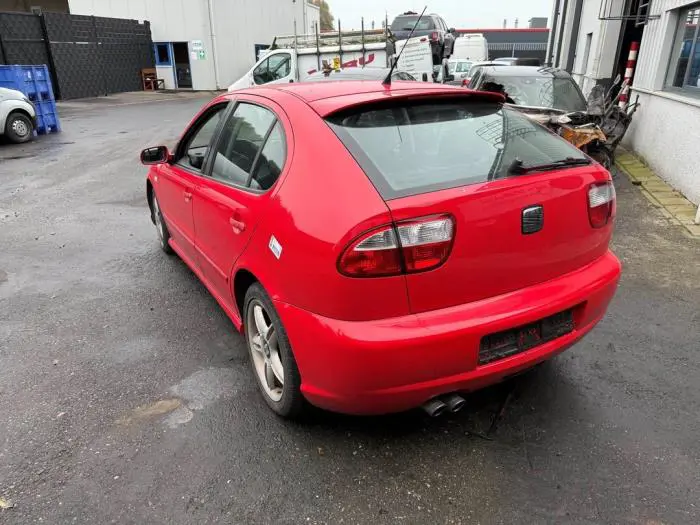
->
xmin=68 ymin=0 xmax=319 ymax=90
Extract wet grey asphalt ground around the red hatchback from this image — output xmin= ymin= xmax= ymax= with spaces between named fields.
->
xmin=0 ymin=95 xmax=700 ymax=525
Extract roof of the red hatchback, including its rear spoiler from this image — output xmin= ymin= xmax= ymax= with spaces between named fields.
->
xmin=233 ymin=80 xmax=505 ymax=117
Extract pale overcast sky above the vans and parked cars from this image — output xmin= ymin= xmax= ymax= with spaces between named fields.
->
xmin=327 ymin=0 xmax=552 ymax=29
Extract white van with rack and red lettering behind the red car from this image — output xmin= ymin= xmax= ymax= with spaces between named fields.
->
xmin=228 ymin=29 xmax=394 ymax=91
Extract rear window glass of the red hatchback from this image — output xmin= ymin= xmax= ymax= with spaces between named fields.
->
xmin=327 ymin=100 xmax=585 ymax=199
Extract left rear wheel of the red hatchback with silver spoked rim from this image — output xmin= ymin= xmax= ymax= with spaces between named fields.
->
xmin=243 ymin=283 xmax=306 ymax=419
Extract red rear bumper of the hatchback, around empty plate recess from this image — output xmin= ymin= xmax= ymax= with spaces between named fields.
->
xmin=275 ymin=252 xmax=620 ymax=414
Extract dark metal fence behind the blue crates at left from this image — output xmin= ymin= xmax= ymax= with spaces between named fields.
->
xmin=0 ymin=13 xmax=154 ymax=99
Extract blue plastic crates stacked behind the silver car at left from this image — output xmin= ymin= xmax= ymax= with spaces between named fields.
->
xmin=0 ymin=65 xmax=61 ymax=135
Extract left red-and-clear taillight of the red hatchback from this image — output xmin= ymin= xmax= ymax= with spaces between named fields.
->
xmin=338 ymin=215 xmax=454 ymax=277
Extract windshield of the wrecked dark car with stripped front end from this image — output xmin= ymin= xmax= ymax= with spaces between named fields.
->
xmin=486 ymin=75 xmax=587 ymax=111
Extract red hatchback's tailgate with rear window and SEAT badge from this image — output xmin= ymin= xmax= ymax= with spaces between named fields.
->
xmin=328 ymin=97 xmax=614 ymax=312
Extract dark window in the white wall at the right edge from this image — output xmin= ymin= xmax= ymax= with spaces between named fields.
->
xmin=666 ymin=6 xmax=700 ymax=93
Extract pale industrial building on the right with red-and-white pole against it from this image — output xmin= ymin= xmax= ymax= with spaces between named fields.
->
xmin=547 ymin=0 xmax=700 ymax=204
